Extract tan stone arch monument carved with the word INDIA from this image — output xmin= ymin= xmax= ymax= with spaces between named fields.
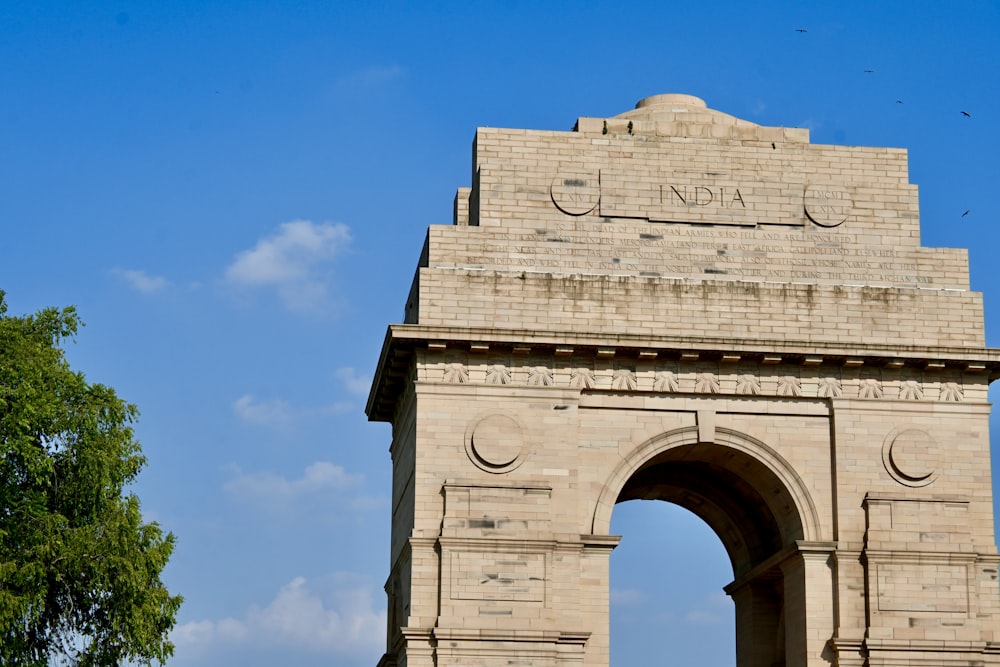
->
xmin=367 ymin=95 xmax=1000 ymax=667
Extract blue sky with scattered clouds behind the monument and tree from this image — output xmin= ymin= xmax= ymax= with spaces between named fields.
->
xmin=0 ymin=0 xmax=1000 ymax=667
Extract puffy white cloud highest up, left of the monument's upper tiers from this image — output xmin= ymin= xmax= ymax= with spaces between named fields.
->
xmin=226 ymin=220 xmax=351 ymax=311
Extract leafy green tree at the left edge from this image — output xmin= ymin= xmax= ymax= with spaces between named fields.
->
xmin=0 ymin=291 xmax=181 ymax=667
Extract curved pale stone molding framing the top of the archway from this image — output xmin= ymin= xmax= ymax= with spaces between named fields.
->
xmin=591 ymin=426 xmax=822 ymax=542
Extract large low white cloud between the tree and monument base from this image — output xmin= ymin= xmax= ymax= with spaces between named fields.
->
xmin=171 ymin=573 xmax=386 ymax=659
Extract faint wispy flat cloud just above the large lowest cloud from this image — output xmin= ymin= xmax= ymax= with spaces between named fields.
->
xmin=223 ymin=461 xmax=363 ymax=504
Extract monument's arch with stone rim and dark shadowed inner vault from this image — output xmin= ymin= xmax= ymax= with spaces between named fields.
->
xmin=594 ymin=429 xmax=816 ymax=667
